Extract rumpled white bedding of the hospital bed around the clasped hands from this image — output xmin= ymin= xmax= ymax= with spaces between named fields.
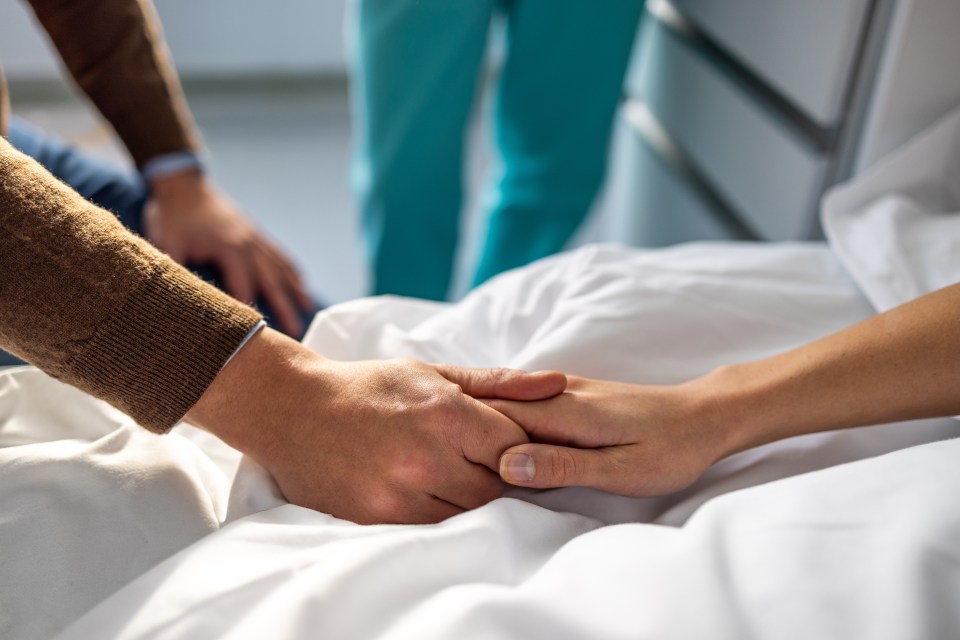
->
xmin=0 ymin=102 xmax=960 ymax=640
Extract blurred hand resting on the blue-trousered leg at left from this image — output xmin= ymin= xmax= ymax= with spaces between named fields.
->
xmin=144 ymin=172 xmax=312 ymax=335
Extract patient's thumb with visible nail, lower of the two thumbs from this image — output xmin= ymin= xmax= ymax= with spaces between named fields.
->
xmin=500 ymin=444 xmax=610 ymax=489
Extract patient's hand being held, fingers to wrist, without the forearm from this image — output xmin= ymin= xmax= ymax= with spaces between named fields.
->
xmin=486 ymin=376 xmax=726 ymax=497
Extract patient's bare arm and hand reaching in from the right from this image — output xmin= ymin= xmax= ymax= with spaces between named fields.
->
xmin=488 ymin=285 xmax=960 ymax=496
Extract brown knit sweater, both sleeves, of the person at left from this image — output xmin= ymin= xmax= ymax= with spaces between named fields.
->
xmin=0 ymin=0 xmax=260 ymax=432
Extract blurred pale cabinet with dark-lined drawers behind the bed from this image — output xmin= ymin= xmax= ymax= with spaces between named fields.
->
xmin=619 ymin=0 xmax=960 ymax=246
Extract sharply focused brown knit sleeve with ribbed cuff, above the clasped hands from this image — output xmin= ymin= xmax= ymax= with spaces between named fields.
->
xmin=0 ymin=138 xmax=261 ymax=432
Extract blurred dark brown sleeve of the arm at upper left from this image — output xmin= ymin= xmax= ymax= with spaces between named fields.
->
xmin=24 ymin=0 xmax=201 ymax=167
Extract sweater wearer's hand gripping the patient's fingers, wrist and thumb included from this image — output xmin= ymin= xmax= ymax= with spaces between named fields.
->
xmin=187 ymin=329 xmax=566 ymax=523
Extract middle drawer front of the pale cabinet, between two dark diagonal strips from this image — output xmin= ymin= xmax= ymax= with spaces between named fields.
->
xmin=627 ymin=20 xmax=828 ymax=240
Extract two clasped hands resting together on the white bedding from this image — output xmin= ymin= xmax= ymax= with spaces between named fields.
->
xmin=187 ymin=329 xmax=721 ymax=523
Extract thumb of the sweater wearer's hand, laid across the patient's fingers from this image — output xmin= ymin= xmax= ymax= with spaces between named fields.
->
xmin=435 ymin=365 xmax=567 ymax=400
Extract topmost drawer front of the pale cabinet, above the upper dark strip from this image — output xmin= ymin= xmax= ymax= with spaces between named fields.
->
xmin=670 ymin=0 xmax=871 ymax=127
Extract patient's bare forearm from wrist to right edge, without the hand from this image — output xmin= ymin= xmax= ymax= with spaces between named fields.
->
xmin=708 ymin=285 xmax=960 ymax=455
